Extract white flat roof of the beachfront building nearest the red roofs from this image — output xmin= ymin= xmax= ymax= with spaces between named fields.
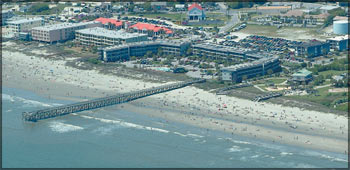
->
xmin=76 ymin=27 xmax=147 ymax=39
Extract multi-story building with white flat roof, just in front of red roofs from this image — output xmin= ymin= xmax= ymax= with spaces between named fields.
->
xmin=75 ymin=27 xmax=148 ymax=47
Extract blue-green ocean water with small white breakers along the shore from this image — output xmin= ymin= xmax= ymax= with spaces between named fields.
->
xmin=2 ymin=87 xmax=348 ymax=168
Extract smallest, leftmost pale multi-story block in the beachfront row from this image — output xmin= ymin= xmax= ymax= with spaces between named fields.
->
xmin=7 ymin=18 xmax=44 ymax=35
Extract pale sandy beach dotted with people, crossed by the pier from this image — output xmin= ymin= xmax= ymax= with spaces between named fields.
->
xmin=2 ymin=42 xmax=348 ymax=154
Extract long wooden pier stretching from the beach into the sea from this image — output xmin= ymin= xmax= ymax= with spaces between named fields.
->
xmin=22 ymin=79 xmax=205 ymax=122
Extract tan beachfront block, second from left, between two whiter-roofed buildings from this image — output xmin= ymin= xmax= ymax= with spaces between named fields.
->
xmin=32 ymin=21 xmax=102 ymax=43
